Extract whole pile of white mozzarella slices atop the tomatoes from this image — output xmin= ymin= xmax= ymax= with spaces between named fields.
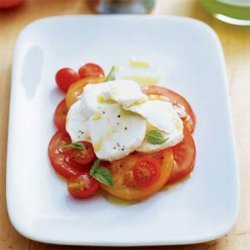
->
xmin=66 ymin=80 xmax=183 ymax=161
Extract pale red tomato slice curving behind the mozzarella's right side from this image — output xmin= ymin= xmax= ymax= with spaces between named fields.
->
xmin=142 ymin=86 xmax=196 ymax=133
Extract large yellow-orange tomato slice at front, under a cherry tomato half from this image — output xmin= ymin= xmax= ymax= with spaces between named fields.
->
xmin=101 ymin=149 xmax=173 ymax=201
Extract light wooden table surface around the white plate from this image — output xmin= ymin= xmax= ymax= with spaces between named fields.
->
xmin=0 ymin=0 xmax=250 ymax=250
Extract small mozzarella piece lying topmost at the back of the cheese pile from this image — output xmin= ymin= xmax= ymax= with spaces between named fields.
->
xmin=110 ymin=80 xmax=147 ymax=107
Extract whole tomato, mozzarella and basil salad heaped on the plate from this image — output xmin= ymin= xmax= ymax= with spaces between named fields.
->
xmin=48 ymin=63 xmax=196 ymax=201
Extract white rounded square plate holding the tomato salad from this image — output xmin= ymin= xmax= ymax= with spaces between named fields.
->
xmin=7 ymin=16 xmax=239 ymax=246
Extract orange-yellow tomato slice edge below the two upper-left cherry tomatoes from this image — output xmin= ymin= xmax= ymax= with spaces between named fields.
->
xmin=66 ymin=77 xmax=104 ymax=108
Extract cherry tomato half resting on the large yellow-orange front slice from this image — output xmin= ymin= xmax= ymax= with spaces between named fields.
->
xmin=133 ymin=156 xmax=160 ymax=188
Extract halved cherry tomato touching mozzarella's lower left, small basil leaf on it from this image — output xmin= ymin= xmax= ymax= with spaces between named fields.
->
xmin=73 ymin=141 xmax=96 ymax=166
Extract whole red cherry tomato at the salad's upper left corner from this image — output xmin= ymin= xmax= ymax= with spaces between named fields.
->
xmin=56 ymin=68 xmax=79 ymax=92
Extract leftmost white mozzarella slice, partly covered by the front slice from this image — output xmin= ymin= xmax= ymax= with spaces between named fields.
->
xmin=66 ymin=100 xmax=89 ymax=142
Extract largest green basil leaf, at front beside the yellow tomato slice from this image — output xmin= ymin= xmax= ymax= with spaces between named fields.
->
xmin=90 ymin=159 xmax=113 ymax=187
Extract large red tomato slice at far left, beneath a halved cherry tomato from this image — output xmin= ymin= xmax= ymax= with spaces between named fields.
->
xmin=48 ymin=131 xmax=83 ymax=179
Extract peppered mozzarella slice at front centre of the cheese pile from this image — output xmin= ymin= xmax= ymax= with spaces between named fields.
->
xmin=88 ymin=104 xmax=146 ymax=161
